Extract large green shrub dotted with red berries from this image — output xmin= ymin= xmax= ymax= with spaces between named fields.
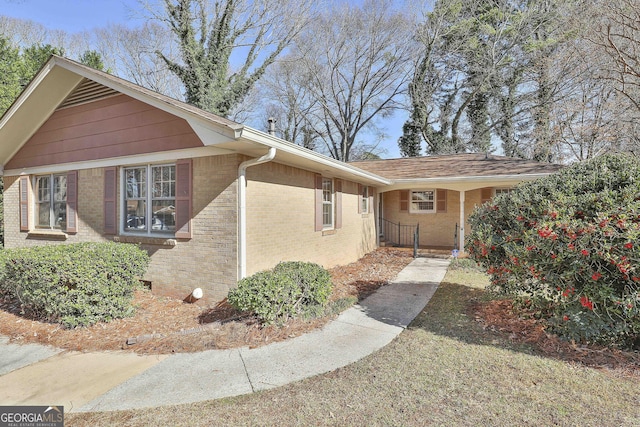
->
xmin=466 ymin=155 xmax=640 ymax=349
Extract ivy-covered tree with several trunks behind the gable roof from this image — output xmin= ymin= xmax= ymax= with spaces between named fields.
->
xmin=148 ymin=0 xmax=309 ymax=116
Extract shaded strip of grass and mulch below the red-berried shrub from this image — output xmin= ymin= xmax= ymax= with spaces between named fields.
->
xmin=409 ymin=282 xmax=640 ymax=378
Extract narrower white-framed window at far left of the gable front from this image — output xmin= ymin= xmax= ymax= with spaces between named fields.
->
xmin=34 ymin=174 xmax=67 ymax=230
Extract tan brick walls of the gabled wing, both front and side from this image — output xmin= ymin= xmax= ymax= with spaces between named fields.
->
xmin=4 ymin=155 xmax=376 ymax=302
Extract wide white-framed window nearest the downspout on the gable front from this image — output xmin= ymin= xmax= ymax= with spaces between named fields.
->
xmin=121 ymin=164 xmax=176 ymax=234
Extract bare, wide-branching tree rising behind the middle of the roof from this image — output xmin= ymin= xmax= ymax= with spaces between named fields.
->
xmin=290 ymin=0 xmax=413 ymax=161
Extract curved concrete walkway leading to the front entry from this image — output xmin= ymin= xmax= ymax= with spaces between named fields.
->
xmin=0 ymin=258 xmax=449 ymax=412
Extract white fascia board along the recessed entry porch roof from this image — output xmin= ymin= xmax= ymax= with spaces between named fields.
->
xmin=383 ymin=173 xmax=550 ymax=191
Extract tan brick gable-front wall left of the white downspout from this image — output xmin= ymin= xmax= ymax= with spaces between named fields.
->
xmin=4 ymin=155 xmax=241 ymax=302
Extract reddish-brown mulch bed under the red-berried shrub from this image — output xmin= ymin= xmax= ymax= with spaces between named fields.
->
xmin=469 ymin=300 xmax=640 ymax=377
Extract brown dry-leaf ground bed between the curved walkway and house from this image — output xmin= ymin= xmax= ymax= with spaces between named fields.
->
xmin=0 ymin=248 xmax=413 ymax=354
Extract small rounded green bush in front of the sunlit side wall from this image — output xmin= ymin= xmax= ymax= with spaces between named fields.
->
xmin=228 ymin=262 xmax=332 ymax=324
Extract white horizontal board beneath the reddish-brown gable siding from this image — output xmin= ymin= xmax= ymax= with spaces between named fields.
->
xmin=3 ymin=147 xmax=233 ymax=176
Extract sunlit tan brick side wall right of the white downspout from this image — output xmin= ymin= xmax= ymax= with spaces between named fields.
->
xmin=247 ymin=162 xmax=376 ymax=274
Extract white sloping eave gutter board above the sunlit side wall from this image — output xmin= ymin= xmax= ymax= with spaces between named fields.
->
xmin=242 ymin=126 xmax=392 ymax=186
